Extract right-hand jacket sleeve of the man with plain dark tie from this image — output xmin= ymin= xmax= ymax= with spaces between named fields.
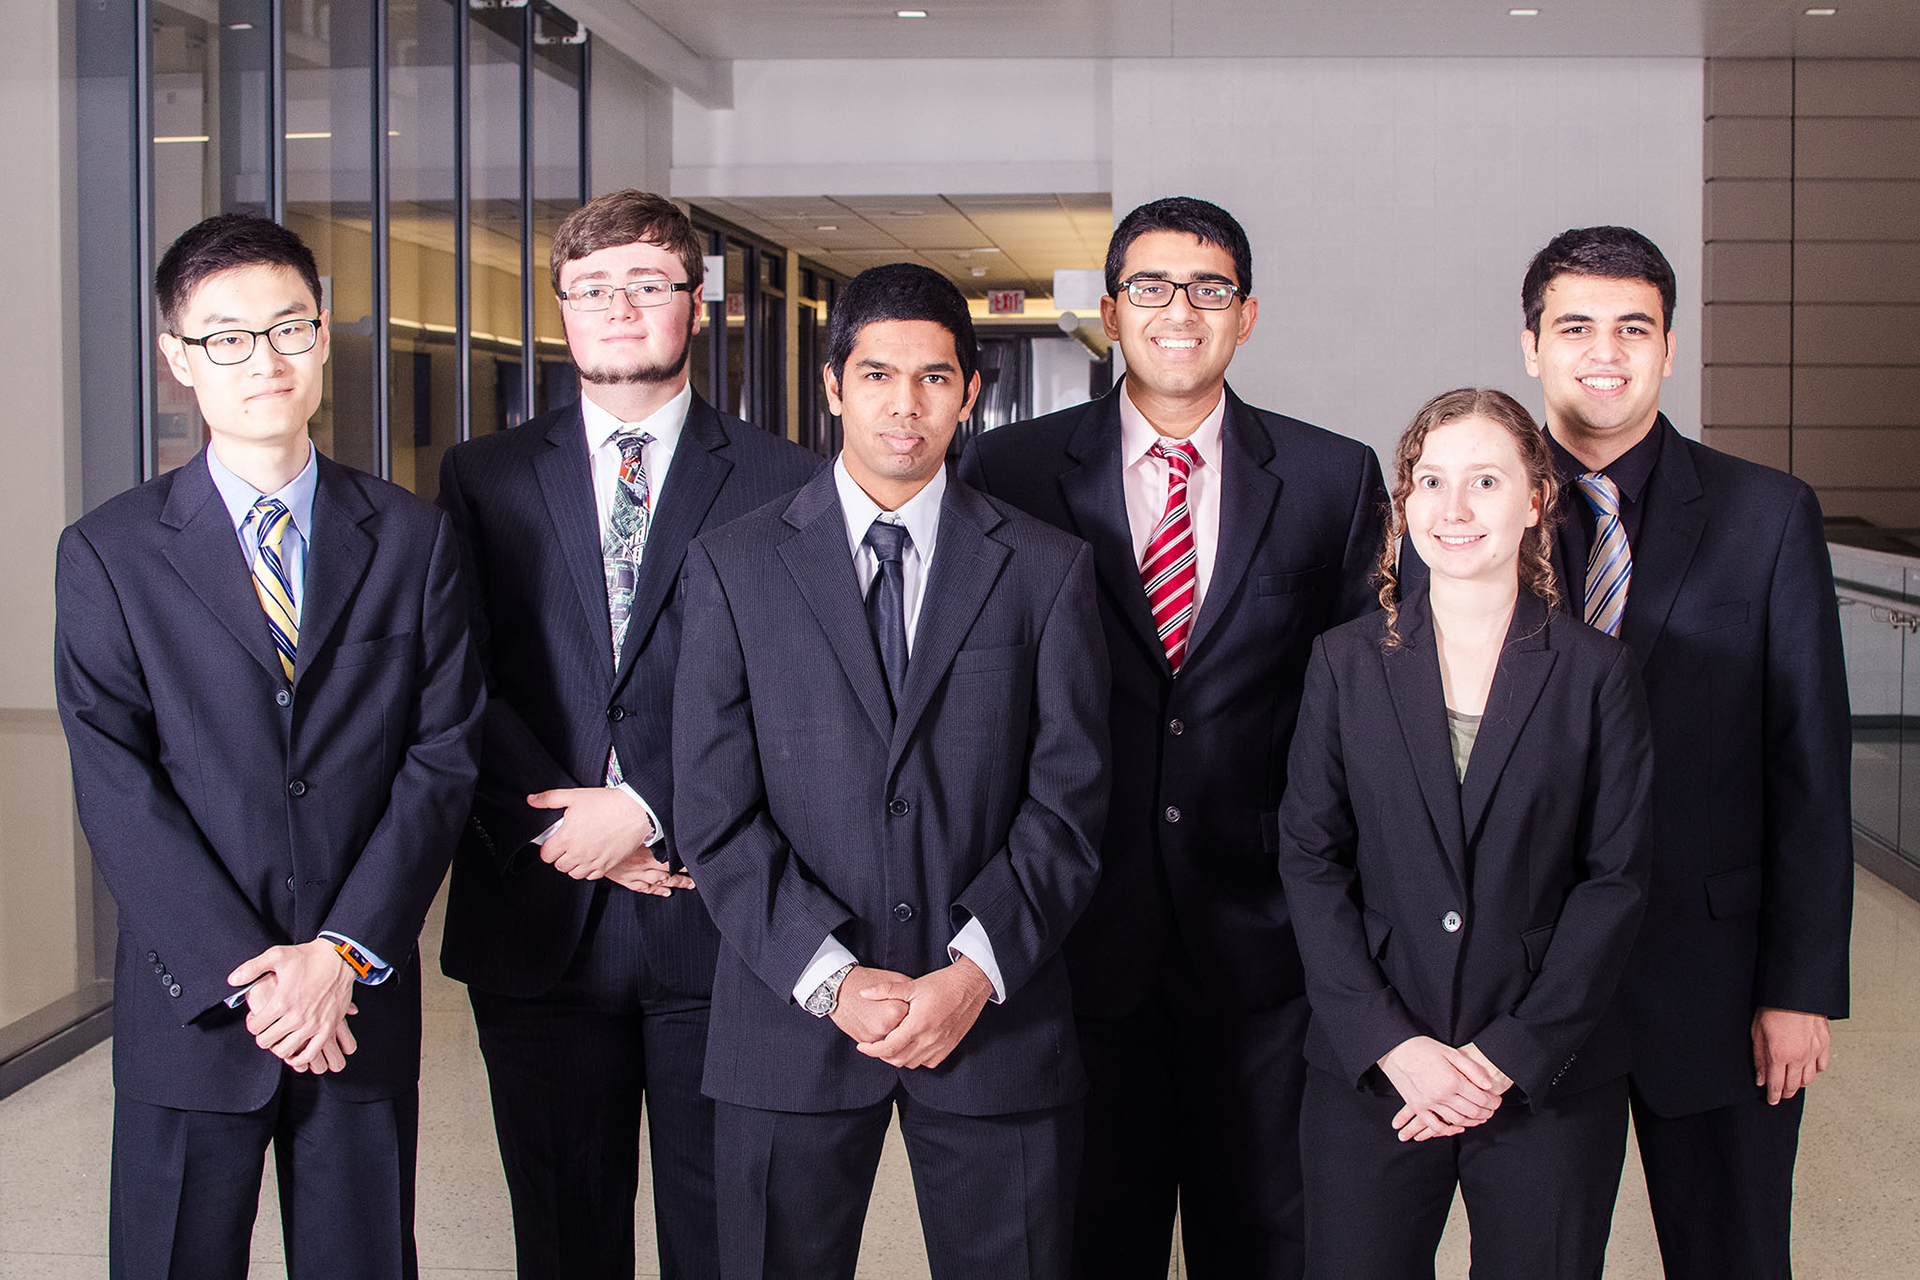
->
xmin=954 ymin=545 xmax=1110 ymax=1000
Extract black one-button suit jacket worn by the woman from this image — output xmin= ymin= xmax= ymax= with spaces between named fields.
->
xmin=1281 ymin=591 xmax=1653 ymax=1107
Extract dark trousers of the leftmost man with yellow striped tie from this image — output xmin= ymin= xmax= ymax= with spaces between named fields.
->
xmin=108 ymin=1069 xmax=420 ymax=1280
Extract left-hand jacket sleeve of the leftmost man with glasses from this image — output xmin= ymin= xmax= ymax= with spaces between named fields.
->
xmin=54 ymin=528 xmax=288 ymax=1023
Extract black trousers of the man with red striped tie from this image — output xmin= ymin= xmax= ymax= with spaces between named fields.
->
xmin=1073 ymin=984 xmax=1308 ymax=1280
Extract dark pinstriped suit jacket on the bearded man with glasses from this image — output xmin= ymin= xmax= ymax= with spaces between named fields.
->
xmin=440 ymin=395 xmax=820 ymax=996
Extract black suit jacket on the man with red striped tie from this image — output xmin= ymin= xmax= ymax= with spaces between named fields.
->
xmin=960 ymin=386 xmax=1384 ymax=1015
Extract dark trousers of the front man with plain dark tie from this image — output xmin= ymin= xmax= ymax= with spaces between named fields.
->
xmin=716 ymin=1090 xmax=1082 ymax=1280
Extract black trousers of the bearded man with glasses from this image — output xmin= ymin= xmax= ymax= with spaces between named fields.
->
xmin=468 ymin=881 xmax=720 ymax=1280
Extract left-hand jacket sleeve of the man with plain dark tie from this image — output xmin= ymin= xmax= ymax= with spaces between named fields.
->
xmin=674 ymin=541 xmax=852 ymax=1000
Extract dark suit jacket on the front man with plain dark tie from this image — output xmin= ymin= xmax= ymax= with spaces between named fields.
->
xmin=674 ymin=470 xmax=1106 ymax=1115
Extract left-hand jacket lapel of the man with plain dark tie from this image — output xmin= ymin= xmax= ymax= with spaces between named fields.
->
xmin=780 ymin=466 xmax=894 ymax=741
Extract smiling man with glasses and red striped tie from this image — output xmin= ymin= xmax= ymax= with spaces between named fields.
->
xmin=962 ymin=198 xmax=1384 ymax=1280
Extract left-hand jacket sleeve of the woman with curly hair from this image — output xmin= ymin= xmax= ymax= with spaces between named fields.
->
xmin=1279 ymin=637 xmax=1428 ymax=1086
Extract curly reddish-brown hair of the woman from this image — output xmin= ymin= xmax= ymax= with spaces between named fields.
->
xmin=1375 ymin=388 xmax=1559 ymax=649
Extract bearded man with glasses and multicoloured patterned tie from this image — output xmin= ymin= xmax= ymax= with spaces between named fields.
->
xmin=440 ymin=190 xmax=820 ymax=1280
